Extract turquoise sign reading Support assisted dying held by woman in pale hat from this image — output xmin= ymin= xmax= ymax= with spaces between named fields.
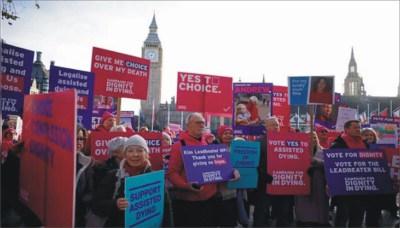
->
xmin=125 ymin=170 xmax=165 ymax=227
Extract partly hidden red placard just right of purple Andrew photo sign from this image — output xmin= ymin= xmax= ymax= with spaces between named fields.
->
xmin=272 ymin=85 xmax=290 ymax=132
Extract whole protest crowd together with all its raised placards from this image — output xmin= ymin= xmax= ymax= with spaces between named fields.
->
xmin=1 ymin=43 xmax=400 ymax=227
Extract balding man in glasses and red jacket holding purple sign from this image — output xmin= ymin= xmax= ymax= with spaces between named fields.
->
xmin=167 ymin=113 xmax=217 ymax=227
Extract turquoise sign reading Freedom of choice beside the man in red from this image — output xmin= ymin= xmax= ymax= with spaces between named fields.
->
xmin=228 ymin=141 xmax=260 ymax=188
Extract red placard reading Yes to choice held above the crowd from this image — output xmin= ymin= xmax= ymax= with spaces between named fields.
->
xmin=176 ymin=72 xmax=232 ymax=116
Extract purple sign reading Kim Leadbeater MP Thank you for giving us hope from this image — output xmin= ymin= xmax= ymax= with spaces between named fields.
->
xmin=182 ymin=144 xmax=233 ymax=184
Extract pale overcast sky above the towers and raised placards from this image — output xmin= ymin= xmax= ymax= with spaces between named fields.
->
xmin=1 ymin=0 xmax=400 ymax=110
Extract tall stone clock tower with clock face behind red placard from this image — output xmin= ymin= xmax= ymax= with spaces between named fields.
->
xmin=140 ymin=14 xmax=162 ymax=128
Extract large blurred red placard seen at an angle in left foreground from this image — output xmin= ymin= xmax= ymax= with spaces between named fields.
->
xmin=20 ymin=90 xmax=77 ymax=227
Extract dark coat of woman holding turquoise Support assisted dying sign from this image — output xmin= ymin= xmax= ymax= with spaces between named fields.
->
xmin=92 ymin=159 xmax=173 ymax=227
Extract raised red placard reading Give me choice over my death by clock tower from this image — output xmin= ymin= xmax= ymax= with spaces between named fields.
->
xmin=91 ymin=47 xmax=150 ymax=100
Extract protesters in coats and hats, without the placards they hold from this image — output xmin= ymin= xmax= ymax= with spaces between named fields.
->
xmin=1 ymin=110 xmax=399 ymax=227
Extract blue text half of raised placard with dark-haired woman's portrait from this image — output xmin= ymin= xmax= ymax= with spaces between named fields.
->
xmin=288 ymin=76 xmax=310 ymax=105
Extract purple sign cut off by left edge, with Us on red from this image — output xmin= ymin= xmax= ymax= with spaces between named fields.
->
xmin=0 ymin=42 xmax=34 ymax=118
